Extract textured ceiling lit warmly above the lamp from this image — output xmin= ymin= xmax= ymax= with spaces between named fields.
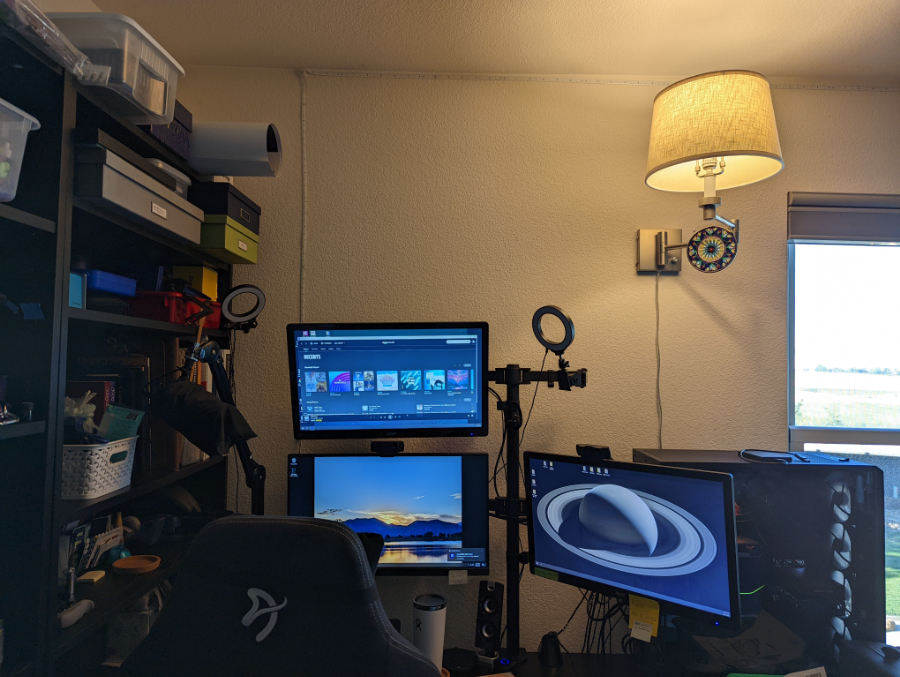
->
xmin=95 ymin=0 xmax=900 ymax=86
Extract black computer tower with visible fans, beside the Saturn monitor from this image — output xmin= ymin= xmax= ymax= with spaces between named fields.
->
xmin=633 ymin=449 xmax=885 ymax=663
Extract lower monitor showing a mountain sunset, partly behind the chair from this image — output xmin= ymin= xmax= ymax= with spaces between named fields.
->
xmin=288 ymin=454 xmax=490 ymax=575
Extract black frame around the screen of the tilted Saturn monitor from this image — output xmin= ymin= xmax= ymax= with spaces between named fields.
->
xmin=523 ymin=451 xmax=741 ymax=630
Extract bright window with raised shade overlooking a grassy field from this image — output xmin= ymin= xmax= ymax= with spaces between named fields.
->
xmin=788 ymin=193 xmax=900 ymax=645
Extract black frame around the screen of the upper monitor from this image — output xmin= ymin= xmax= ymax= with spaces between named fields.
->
xmin=287 ymin=322 xmax=490 ymax=440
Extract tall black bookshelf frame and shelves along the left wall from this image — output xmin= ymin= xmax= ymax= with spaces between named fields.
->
xmin=0 ymin=23 xmax=232 ymax=677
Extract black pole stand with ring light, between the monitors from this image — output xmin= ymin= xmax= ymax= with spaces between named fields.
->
xmin=488 ymin=306 xmax=587 ymax=665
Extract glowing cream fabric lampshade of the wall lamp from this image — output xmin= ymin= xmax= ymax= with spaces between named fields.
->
xmin=645 ymin=71 xmax=784 ymax=192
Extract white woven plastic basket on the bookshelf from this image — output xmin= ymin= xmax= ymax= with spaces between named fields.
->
xmin=62 ymin=437 xmax=138 ymax=500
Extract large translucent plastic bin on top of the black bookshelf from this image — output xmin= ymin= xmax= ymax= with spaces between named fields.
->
xmin=47 ymin=12 xmax=184 ymax=125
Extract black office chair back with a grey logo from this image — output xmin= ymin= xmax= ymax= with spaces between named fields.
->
xmin=122 ymin=515 xmax=440 ymax=677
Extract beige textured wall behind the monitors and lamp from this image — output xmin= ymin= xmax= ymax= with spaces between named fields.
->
xmin=179 ymin=68 xmax=900 ymax=650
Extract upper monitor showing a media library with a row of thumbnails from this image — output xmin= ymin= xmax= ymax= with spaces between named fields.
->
xmin=287 ymin=322 xmax=489 ymax=439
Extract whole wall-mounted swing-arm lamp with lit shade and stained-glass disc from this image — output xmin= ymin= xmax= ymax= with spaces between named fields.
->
xmin=636 ymin=71 xmax=784 ymax=273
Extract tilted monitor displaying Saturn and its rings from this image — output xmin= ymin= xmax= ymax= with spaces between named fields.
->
xmin=524 ymin=452 xmax=740 ymax=629
